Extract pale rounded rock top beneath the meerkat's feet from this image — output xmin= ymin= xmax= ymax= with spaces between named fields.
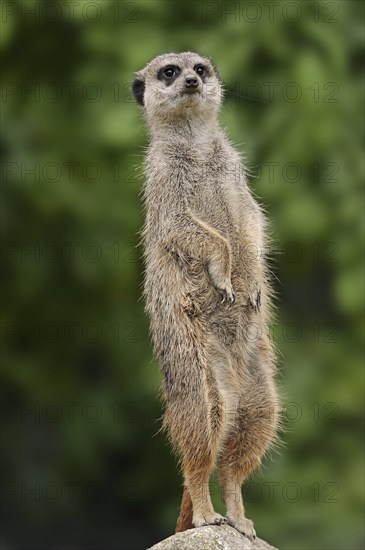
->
xmin=149 ymin=525 xmax=277 ymax=550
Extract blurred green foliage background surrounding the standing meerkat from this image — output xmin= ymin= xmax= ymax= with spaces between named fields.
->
xmin=1 ymin=0 xmax=363 ymax=550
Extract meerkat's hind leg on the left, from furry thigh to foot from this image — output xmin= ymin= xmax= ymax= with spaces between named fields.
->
xmin=165 ymin=338 xmax=226 ymax=530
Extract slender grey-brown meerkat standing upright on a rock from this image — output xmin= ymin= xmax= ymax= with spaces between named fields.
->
xmin=132 ymin=52 xmax=279 ymax=537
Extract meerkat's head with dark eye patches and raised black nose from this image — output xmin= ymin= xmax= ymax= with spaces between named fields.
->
xmin=132 ymin=52 xmax=223 ymax=133
